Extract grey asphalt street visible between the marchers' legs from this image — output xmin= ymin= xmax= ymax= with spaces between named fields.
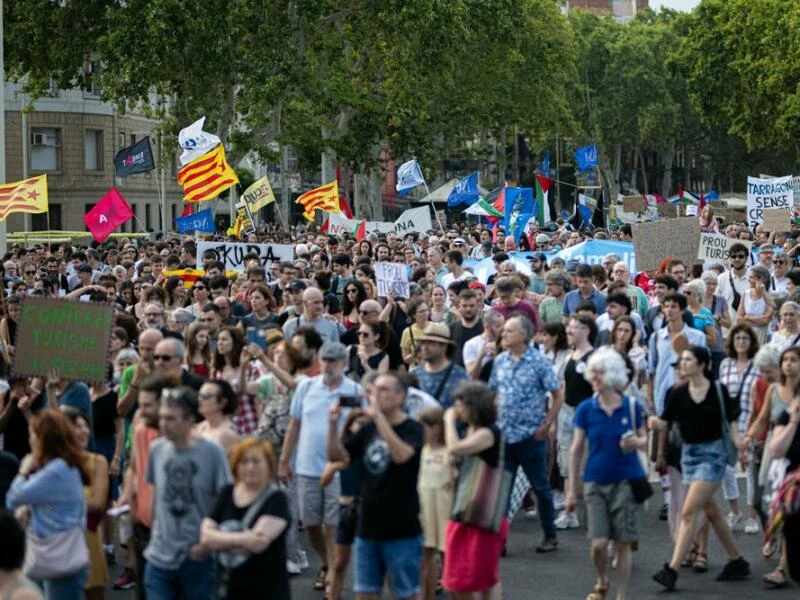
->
xmin=110 ymin=490 xmax=800 ymax=600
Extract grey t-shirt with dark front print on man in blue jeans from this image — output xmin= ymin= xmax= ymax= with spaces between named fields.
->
xmin=144 ymin=438 xmax=233 ymax=570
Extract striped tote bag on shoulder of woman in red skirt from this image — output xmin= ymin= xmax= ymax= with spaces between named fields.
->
xmin=450 ymin=434 xmax=511 ymax=532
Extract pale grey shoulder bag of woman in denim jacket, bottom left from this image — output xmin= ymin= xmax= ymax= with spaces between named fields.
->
xmin=22 ymin=527 xmax=89 ymax=581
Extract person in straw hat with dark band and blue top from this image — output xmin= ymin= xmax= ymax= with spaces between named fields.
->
xmin=411 ymin=323 xmax=468 ymax=410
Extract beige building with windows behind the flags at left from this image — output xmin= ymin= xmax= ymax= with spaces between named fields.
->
xmin=5 ymin=83 xmax=183 ymax=232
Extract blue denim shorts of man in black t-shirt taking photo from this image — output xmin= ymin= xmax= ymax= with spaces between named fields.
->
xmin=353 ymin=535 xmax=422 ymax=599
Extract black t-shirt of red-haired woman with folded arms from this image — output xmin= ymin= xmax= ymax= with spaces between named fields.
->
xmin=208 ymin=485 xmax=292 ymax=600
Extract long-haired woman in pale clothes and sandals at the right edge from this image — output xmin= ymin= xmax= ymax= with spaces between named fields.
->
xmin=744 ymin=346 xmax=800 ymax=587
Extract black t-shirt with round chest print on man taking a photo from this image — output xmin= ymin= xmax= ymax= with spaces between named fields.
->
xmin=345 ymin=419 xmax=424 ymax=541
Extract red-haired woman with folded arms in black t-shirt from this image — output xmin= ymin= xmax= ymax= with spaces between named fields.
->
xmin=200 ymin=438 xmax=291 ymax=600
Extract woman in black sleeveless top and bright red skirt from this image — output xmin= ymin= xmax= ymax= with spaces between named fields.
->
xmin=442 ymin=381 xmax=508 ymax=600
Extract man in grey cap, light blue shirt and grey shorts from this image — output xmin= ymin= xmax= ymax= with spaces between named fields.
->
xmin=278 ymin=340 xmax=364 ymax=591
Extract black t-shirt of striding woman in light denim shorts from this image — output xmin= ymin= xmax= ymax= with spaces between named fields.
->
xmin=661 ymin=383 xmax=742 ymax=444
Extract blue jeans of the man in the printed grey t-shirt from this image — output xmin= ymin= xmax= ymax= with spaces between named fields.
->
xmin=144 ymin=558 xmax=214 ymax=600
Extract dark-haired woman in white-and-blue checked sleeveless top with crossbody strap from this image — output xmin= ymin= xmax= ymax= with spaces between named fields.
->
xmin=719 ymin=323 xmax=760 ymax=531
